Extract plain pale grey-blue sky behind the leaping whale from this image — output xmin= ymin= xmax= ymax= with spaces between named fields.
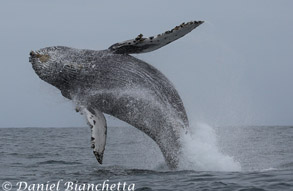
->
xmin=0 ymin=0 xmax=293 ymax=127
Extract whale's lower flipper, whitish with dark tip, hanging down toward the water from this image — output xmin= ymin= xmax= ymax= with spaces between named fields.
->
xmin=83 ymin=108 xmax=107 ymax=164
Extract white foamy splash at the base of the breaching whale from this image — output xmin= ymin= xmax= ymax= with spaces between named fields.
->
xmin=180 ymin=123 xmax=241 ymax=171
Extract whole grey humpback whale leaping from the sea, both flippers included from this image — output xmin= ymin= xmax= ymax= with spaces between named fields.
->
xmin=29 ymin=21 xmax=203 ymax=169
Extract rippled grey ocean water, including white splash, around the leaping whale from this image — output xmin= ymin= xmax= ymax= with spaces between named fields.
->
xmin=0 ymin=124 xmax=293 ymax=191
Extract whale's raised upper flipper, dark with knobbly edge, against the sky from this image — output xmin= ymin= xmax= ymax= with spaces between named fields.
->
xmin=109 ymin=21 xmax=203 ymax=54
